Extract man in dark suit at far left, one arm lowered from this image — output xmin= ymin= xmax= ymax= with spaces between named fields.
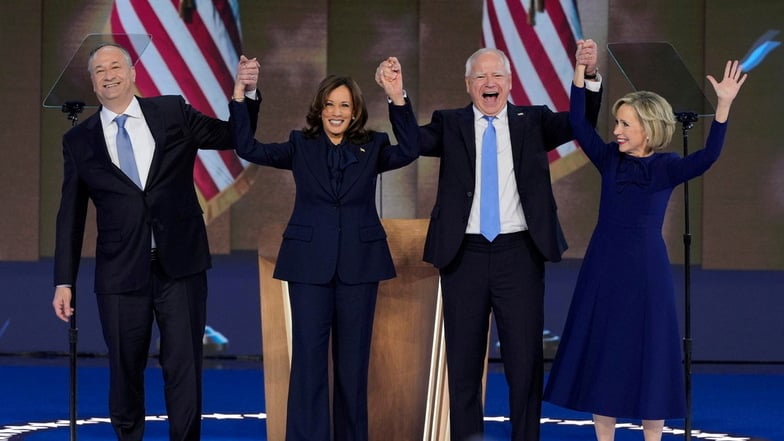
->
xmin=52 ymin=44 xmax=259 ymax=441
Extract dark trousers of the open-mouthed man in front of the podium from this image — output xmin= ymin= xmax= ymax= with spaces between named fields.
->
xmin=441 ymin=232 xmax=544 ymax=441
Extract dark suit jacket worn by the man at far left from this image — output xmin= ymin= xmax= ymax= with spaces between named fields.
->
xmin=54 ymin=96 xmax=259 ymax=294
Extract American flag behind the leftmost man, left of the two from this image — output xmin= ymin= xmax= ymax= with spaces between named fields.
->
xmin=109 ymin=0 xmax=255 ymax=223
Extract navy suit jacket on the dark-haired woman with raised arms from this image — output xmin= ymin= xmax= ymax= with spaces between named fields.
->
xmin=229 ymin=98 xmax=419 ymax=284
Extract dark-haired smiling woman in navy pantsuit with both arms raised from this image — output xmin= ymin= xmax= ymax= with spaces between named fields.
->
xmin=229 ymin=58 xmax=419 ymax=441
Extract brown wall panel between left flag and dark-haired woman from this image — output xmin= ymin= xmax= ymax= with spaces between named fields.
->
xmin=231 ymin=0 xmax=328 ymax=250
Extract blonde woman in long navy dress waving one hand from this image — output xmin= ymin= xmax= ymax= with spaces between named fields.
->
xmin=544 ymin=54 xmax=747 ymax=441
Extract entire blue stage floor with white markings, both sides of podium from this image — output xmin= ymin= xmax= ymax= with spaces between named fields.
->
xmin=0 ymin=360 xmax=784 ymax=441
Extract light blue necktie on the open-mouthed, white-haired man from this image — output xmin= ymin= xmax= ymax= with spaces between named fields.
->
xmin=479 ymin=116 xmax=501 ymax=242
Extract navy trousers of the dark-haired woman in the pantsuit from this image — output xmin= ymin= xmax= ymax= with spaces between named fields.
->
xmin=286 ymin=277 xmax=378 ymax=441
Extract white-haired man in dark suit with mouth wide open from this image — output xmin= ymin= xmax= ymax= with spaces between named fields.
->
xmin=420 ymin=40 xmax=601 ymax=441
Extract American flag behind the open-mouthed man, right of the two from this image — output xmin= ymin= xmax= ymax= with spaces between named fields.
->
xmin=482 ymin=0 xmax=586 ymax=180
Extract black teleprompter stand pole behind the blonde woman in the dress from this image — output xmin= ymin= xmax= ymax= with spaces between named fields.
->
xmin=675 ymin=112 xmax=697 ymax=441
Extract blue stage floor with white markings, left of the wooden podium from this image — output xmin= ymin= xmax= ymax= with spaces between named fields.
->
xmin=0 ymin=361 xmax=266 ymax=441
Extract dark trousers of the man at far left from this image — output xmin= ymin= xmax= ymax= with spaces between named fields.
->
xmin=97 ymin=262 xmax=207 ymax=441
